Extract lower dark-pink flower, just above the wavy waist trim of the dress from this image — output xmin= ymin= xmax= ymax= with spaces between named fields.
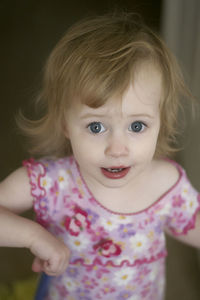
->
xmin=93 ymin=239 xmax=121 ymax=257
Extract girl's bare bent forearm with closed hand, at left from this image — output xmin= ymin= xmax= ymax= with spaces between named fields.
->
xmin=0 ymin=207 xmax=69 ymax=275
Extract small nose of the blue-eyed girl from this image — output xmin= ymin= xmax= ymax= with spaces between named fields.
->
xmin=105 ymin=137 xmax=129 ymax=158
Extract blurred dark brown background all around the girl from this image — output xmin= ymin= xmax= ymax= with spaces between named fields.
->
xmin=0 ymin=0 xmax=200 ymax=300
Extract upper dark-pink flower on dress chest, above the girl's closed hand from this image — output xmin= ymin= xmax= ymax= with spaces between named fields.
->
xmin=64 ymin=206 xmax=90 ymax=236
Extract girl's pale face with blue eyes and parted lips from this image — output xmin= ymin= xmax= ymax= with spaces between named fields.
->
xmin=65 ymin=63 xmax=162 ymax=188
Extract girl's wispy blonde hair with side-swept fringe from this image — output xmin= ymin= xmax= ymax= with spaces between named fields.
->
xmin=18 ymin=13 xmax=189 ymax=157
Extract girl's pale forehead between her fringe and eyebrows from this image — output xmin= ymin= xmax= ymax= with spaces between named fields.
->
xmin=73 ymin=63 xmax=163 ymax=116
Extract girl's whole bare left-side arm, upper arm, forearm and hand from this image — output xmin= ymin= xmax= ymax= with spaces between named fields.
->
xmin=0 ymin=168 xmax=69 ymax=275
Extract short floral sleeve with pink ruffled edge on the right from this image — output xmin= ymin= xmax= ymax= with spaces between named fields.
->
xmin=166 ymin=169 xmax=200 ymax=236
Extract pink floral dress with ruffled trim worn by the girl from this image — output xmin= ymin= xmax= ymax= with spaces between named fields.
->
xmin=24 ymin=157 xmax=200 ymax=300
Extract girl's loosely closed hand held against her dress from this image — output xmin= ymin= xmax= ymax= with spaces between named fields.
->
xmin=29 ymin=224 xmax=70 ymax=276
